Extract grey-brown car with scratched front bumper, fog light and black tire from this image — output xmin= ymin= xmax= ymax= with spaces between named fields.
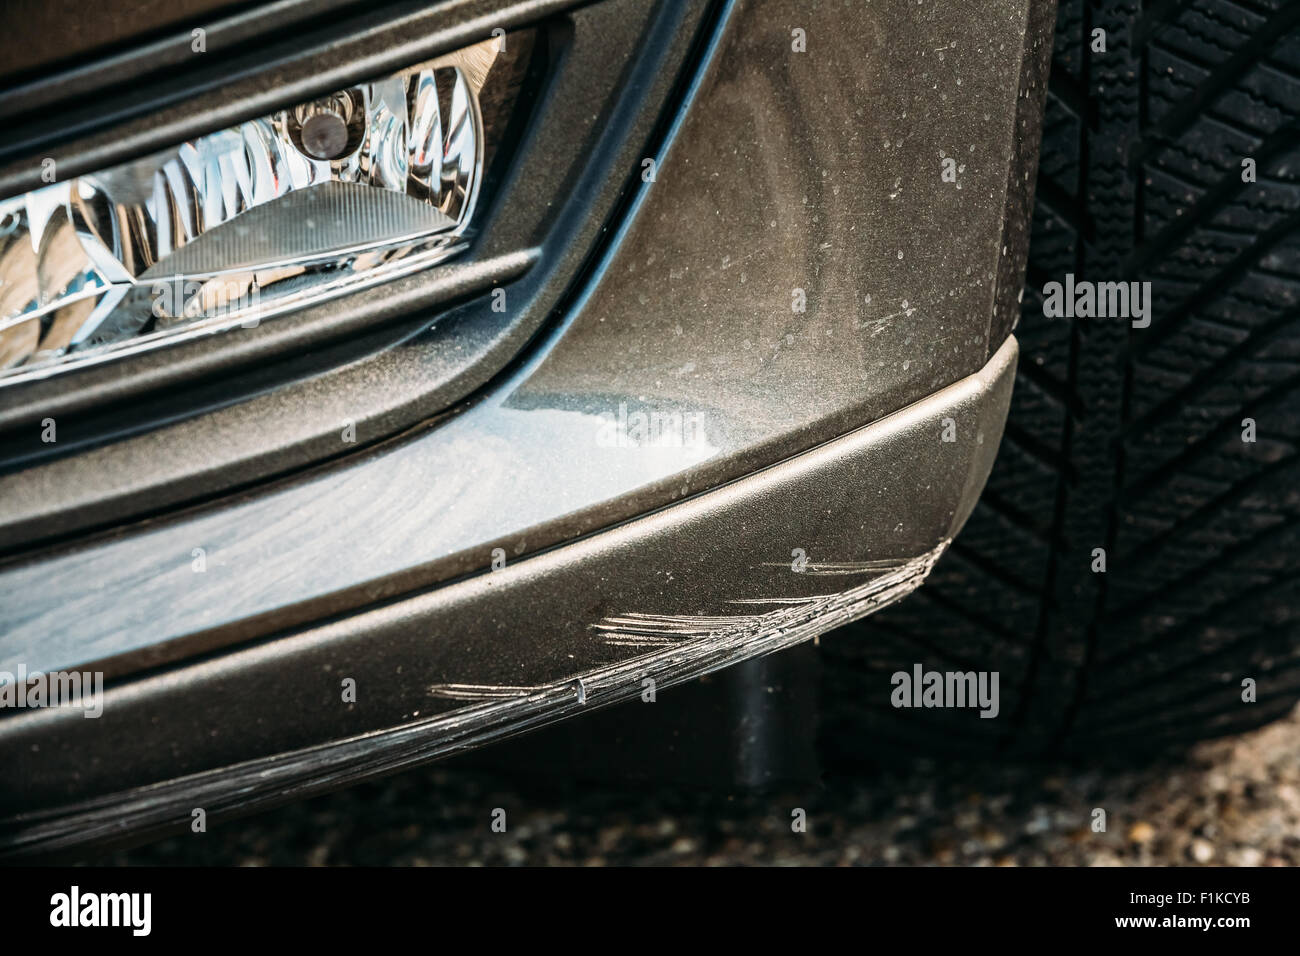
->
xmin=0 ymin=0 xmax=1300 ymax=858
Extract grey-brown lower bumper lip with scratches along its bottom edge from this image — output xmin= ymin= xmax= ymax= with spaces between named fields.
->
xmin=0 ymin=338 xmax=1017 ymax=856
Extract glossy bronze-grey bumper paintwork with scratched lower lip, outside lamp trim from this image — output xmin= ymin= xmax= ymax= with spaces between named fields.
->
xmin=0 ymin=0 xmax=1050 ymax=849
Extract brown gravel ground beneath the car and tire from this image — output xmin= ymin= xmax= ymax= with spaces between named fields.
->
xmin=87 ymin=711 xmax=1300 ymax=866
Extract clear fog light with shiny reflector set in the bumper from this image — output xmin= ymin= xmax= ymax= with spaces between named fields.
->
xmin=0 ymin=38 xmax=502 ymax=385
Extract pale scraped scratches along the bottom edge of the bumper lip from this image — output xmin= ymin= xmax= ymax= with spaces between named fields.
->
xmin=0 ymin=540 xmax=949 ymax=857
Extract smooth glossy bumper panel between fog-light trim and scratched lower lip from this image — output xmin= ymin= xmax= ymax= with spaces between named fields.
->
xmin=0 ymin=3 xmax=1045 ymax=670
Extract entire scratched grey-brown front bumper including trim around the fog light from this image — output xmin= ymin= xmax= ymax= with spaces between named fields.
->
xmin=0 ymin=0 xmax=1050 ymax=855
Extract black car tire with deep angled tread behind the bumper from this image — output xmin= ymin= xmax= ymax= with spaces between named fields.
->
xmin=822 ymin=0 xmax=1300 ymax=758
